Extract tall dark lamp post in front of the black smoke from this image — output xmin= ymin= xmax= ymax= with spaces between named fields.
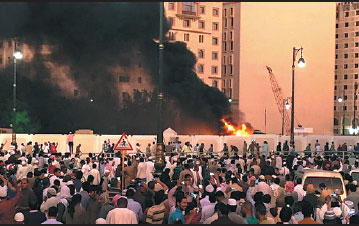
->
xmin=155 ymin=2 xmax=165 ymax=173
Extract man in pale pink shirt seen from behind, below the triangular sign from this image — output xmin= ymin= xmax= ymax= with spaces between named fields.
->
xmin=106 ymin=198 xmax=138 ymax=224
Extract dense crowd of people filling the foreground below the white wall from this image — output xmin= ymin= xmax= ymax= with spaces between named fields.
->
xmin=0 ymin=140 xmax=359 ymax=224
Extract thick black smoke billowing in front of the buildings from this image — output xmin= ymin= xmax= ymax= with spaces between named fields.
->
xmin=0 ymin=2 xmax=231 ymax=134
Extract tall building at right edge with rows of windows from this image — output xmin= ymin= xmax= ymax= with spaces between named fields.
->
xmin=333 ymin=2 xmax=359 ymax=135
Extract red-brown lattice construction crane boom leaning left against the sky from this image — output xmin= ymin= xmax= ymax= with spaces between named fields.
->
xmin=266 ymin=66 xmax=290 ymax=134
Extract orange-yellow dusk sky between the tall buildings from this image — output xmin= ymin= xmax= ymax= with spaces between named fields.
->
xmin=240 ymin=2 xmax=336 ymax=135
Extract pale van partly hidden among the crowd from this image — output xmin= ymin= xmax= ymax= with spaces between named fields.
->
xmin=302 ymin=169 xmax=347 ymax=200
